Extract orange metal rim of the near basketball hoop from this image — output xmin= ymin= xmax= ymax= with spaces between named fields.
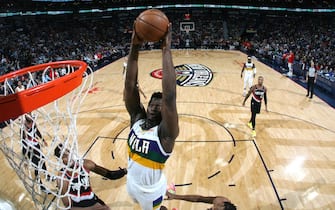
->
xmin=0 ymin=60 xmax=87 ymax=122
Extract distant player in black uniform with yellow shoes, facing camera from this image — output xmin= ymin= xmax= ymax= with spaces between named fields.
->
xmin=242 ymin=76 xmax=268 ymax=137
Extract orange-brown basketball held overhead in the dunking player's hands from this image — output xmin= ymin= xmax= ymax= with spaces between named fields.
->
xmin=135 ymin=9 xmax=169 ymax=42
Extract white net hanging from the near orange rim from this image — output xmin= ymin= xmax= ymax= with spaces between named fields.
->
xmin=0 ymin=61 xmax=93 ymax=209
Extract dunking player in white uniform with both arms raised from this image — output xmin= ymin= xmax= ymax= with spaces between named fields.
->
xmin=124 ymin=24 xmax=179 ymax=210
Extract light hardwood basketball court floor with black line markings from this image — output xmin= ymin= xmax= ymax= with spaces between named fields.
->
xmin=0 ymin=50 xmax=335 ymax=210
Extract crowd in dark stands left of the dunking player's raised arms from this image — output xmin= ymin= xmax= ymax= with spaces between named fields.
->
xmin=0 ymin=13 xmax=134 ymax=74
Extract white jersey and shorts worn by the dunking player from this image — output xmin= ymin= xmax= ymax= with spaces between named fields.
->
xmin=127 ymin=119 xmax=171 ymax=210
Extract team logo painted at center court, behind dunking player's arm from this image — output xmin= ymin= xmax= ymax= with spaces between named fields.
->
xmin=150 ymin=64 xmax=213 ymax=87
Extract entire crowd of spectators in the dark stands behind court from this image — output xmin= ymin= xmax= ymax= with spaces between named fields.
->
xmin=0 ymin=9 xmax=335 ymax=95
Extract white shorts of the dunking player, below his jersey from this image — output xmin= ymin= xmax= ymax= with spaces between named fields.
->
xmin=127 ymin=174 xmax=167 ymax=210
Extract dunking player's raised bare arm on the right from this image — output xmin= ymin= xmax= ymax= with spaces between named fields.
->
xmin=159 ymin=23 xmax=179 ymax=152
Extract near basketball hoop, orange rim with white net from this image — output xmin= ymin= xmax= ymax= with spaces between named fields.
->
xmin=0 ymin=60 xmax=93 ymax=209
